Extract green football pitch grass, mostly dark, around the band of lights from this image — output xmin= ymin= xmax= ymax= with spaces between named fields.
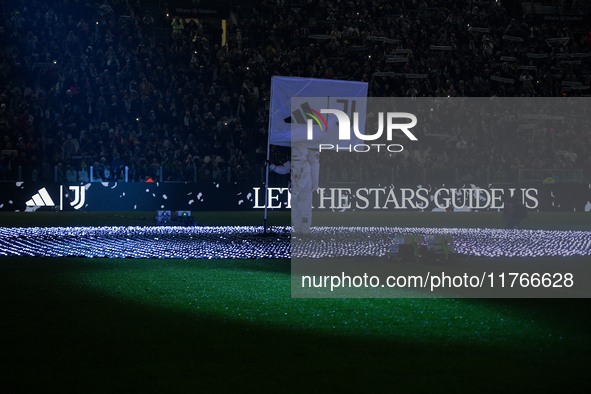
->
xmin=0 ymin=212 xmax=591 ymax=393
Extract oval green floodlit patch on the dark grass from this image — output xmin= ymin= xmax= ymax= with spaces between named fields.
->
xmin=67 ymin=259 xmax=575 ymax=347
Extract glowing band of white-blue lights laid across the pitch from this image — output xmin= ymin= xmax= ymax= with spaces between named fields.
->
xmin=0 ymin=226 xmax=591 ymax=259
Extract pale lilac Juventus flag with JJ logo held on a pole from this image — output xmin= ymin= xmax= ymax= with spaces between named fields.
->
xmin=269 ymin=77 xmax=368 ymax=147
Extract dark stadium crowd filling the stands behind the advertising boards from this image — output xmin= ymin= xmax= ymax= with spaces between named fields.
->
xmin=0 ymin=0 xmax=591 ymax=186
